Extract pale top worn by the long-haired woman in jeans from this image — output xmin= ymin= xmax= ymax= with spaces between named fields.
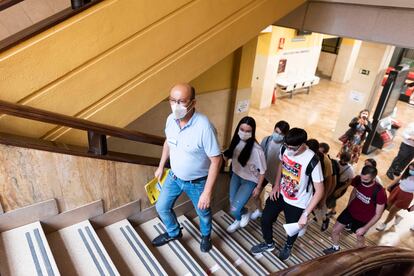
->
xmin=232 ymin=140 xmax=266 ymax=183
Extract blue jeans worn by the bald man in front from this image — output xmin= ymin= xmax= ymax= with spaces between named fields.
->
xmin=155 ymin=171 xmax=212 ymax=237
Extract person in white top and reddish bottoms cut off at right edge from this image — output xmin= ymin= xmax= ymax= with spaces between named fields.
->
xmin=376 ymin=162 xmax=414 ymax=231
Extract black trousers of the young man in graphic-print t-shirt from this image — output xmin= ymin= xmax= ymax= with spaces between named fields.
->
xmin=262 ymin=195 xmax=304 ymax=246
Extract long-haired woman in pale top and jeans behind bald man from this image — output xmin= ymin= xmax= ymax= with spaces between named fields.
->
xmin=224 ymin=116 xmax=266 ymax=233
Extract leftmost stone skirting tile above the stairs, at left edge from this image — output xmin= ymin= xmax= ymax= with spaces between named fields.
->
xmin=0 ymin=198 xmax=59 ymax=232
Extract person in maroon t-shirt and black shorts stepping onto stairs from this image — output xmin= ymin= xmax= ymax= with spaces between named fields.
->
xmin=323 ymin=166 xmax=387 ymax=254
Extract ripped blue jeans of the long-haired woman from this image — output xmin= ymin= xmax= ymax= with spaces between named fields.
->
xmin=230 ymin=172 xmax=256 ymax=220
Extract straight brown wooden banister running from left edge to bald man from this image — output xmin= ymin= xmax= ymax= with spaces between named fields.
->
xmin=0 ymin=101 xmax=165 ymax=146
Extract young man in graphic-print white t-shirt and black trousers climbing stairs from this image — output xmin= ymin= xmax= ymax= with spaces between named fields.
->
xmin=251 ymin=128 xmax=324 ymax=261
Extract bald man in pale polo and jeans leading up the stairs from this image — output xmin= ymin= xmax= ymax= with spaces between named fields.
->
xmin=152 ymin=84 xmax=222 ymax=252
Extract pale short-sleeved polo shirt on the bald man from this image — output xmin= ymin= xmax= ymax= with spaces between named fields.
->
xmin=165 ymin=112 xmax=221 ymax=181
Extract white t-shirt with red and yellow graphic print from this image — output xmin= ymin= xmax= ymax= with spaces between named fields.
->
xmin=280 ymin=148 xmax=323 ymax=209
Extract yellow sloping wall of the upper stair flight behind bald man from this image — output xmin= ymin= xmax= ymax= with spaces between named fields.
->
xmin=0 ymin=0 xmax=304 ymax=147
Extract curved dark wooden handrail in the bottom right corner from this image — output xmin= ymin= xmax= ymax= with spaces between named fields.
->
xmin=271 ymin=246 xmax=414 ymax=276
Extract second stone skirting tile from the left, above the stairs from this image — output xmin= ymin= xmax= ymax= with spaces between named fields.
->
xmin=41 ymin=199 xmax=103 ymax=233
